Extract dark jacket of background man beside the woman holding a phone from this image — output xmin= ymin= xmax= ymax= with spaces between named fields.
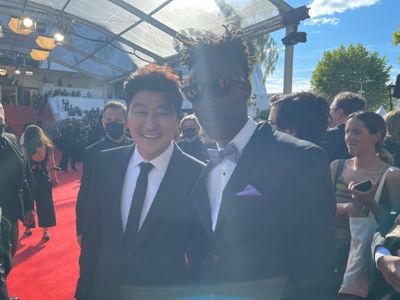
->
xmin=322 ymin=123 xmax=351 ymax=162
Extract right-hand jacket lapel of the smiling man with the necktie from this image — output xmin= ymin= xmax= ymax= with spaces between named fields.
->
xmin=127 ymin=145 xmax=182 ymax=255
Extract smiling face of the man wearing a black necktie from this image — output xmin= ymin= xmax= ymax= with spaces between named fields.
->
xmin=128 ymin=90 xmax=179 ymax=160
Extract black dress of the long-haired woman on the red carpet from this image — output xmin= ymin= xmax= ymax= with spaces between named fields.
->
xmin=29 ymin=148 xmax=56 ymax=228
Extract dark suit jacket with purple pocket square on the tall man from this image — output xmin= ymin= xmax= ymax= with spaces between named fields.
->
xmin=192 ymin=123 xmax=336 ymax=300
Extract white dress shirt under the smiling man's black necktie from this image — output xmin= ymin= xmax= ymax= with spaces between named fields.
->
xmin=121 ymin=142 xmax=174 ymax=231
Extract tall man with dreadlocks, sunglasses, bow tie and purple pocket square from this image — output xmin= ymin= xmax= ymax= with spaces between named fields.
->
xmin=181 ymin=27 xmax=335 ymax=300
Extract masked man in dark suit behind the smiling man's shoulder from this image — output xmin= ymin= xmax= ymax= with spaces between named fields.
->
xmin=76 ymin=101 xmax=133 ymax=244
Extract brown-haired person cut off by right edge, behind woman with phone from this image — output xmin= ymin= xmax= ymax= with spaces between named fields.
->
xmin=383 ymin=109 xmax=400 ymax=168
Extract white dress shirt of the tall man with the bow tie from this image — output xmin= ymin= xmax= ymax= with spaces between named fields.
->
xmin=206 ymin=118 xmax=257 ymax=231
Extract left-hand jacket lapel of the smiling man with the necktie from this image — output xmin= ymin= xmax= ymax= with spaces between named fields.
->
xmin=107 ymin=145 xmax=135 ymax=243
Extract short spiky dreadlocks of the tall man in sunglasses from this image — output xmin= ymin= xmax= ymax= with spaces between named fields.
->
xmin=178 ymin=25 xmax=253 ymax=78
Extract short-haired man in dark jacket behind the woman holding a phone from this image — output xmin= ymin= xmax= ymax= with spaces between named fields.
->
xmin=322 ymin=92 xmax=366 ymax=162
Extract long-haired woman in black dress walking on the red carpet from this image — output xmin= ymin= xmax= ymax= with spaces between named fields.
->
xmin=22 ymin=125 xmax=59 ymax=241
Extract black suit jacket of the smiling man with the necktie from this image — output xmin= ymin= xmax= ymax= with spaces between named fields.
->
xmin=76 ymin=145 xmax=205 ymax=299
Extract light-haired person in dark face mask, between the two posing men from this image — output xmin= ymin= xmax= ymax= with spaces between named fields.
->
xmin=178 ymin=115 xmax=206 ymax=162
